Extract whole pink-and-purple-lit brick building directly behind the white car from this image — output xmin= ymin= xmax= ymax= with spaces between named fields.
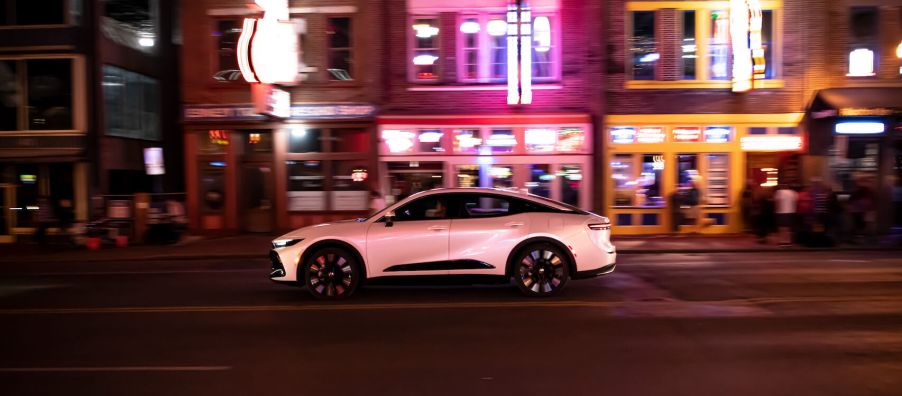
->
xmin=377 ymin=0 xmax=604 ymax=209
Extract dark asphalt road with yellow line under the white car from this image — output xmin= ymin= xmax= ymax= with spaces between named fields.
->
xmin=0 ymin=252 xmax=902 ymax=396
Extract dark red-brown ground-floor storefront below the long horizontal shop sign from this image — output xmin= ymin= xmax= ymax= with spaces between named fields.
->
xmin=184 ymin=104 xmax=376 ymax=232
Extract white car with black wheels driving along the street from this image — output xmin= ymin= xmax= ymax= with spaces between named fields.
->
xmin=269 ymin=188 xmax=617 ymax=299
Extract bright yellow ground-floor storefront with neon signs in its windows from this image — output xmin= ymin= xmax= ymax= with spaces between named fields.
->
xmin=604 ymin=113 xmax=805 ymax=234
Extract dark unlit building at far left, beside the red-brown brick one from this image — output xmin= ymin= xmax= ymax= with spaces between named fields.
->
xmin=0 ymin=0 xmax=182 ymax=242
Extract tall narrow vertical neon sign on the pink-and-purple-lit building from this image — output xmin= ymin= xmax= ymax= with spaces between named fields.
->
xmin=507 ymin=0 xmax=532 ymax=105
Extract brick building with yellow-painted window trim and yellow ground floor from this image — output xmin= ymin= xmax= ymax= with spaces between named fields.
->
xmin=599 ymin=0 xmax=817 ymax=233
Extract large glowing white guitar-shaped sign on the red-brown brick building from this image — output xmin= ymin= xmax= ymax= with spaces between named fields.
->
xmin=237 ymin=0 xmax=300 ymax=84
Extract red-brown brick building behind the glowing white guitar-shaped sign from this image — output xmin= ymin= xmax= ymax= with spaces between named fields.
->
xmin=181 ymin=0 xmax=382 ymax=232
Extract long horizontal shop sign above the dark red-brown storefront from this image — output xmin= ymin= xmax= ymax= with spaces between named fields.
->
xmin=182 ymin=103 xmax=376 ymax=122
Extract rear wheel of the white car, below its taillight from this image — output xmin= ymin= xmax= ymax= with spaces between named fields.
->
xmin=511 ymin=243 xmax=570 ymax=297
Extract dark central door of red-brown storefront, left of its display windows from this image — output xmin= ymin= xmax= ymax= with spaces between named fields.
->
xmin=239 ymin=163 xmax=274 ymax=233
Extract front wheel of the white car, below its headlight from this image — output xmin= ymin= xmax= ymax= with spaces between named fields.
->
xmin=302 ymin=247 xmax=360 ymax=300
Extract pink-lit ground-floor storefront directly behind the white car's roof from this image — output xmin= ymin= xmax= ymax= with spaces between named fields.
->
xmin=378 ymin=114 xmax=593 ymax=209
